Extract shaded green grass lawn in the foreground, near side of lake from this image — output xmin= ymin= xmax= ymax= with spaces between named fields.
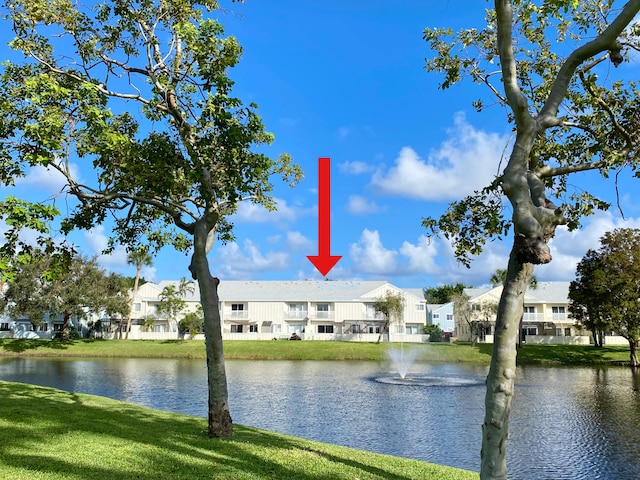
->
xmin=0 ymin=382 xmax=479 ymax=480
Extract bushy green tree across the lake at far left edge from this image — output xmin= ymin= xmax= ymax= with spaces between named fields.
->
xmin=0 ymin=250 xmax=129 ymax=341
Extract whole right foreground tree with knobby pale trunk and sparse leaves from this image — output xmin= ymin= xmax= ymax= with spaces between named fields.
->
xmin=423 ymin=0 xmax=640 ymax=480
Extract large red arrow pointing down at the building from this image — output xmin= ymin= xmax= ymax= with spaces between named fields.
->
xmin=307 ymin=158 xmax=342 ymax=277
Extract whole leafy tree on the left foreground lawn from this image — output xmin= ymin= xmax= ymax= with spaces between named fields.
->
xmin=0 ymin=0 xmax=301 ymax=437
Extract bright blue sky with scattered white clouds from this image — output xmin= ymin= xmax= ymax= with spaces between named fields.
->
xmin=2 ymin=0 xmax=640 ymax=288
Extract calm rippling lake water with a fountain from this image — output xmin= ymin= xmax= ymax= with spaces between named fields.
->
xmin=0 ymin=359 xmax=640 ymax=480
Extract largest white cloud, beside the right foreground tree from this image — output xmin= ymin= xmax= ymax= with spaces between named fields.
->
xmin=371 ymin=114 xmax=508 ymax=200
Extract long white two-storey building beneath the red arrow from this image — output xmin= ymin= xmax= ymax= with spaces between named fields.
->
xmin=129 ymin=281 xmax=428 ymax=342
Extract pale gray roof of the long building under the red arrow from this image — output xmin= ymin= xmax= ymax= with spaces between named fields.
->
xmin=158 ymin=280 xmax=422 ymax=302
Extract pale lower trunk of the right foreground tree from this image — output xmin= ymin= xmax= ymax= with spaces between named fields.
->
xmin=480 ymin=249 xmax=533 ymax=480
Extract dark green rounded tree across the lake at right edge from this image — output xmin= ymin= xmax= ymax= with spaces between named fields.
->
xmin=569 ymin=228 xmax=640 ymax=368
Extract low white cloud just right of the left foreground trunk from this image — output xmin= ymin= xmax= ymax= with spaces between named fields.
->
xmin=218 ymin=240 xmax=289 ymax=279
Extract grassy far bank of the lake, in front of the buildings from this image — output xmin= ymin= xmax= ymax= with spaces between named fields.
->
xmin=0 ymin=339 xmax=629 ymax=366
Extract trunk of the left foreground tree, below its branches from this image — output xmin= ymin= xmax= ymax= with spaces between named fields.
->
xmin=189 ymin=220 xmax=233 ymax=438
